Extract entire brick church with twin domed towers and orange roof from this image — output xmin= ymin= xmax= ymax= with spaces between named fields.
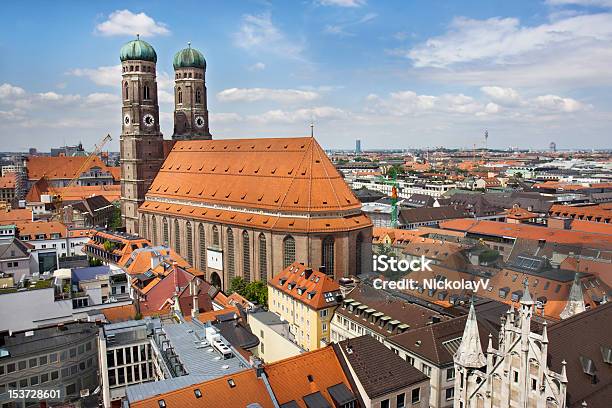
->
xmin=121 ymin=39 xmax=372 ymax=289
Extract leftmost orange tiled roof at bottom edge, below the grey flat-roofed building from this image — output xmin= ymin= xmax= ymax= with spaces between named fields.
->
xmin=130 ymin=369 xmax=274 ymax=408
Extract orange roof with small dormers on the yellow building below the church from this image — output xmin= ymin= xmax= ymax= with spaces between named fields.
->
xmin=268 ymin=262 xmax=340 ymax=309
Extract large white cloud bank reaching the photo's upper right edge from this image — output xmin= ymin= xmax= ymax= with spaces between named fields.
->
xmin=402 ymin=13 xmax=612 ymax=86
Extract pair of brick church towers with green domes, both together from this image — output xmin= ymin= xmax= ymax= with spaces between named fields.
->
xmin=120 ymin=38 xmax=212 ymax=233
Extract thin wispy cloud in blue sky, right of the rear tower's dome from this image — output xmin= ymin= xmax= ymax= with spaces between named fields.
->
xmin=234 ymin=13 xmax=303 ymax=59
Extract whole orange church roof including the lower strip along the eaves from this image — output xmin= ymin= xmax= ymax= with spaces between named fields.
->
xmin=140 ymin=137 xmax=371 ymax=231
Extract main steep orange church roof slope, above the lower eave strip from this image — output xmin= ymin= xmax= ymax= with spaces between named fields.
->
xmin=147 ymin=137 xmax=361 ymax=212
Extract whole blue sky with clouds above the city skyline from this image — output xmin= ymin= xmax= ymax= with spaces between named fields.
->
xmin=0 ymin=0 xmax=612 ymax=150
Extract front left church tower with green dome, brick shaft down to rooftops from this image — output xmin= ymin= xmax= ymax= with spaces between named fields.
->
xmin=120 ymin=38 xmax=164 ymax=234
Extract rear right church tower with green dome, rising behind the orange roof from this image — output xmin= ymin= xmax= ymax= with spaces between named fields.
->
xmin=172 ymin=43 xmax=212 ymax=140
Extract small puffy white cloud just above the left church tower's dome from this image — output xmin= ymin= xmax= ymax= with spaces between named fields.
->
xmin=95 ymin=10 xmax=170 ymax=37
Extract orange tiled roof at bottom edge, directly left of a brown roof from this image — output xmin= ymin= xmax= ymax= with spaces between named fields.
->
xmin=265 ymin=346 xmax=358 ymax=408
